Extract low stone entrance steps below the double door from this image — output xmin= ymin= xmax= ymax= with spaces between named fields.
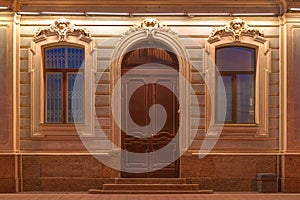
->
xmin=89 ymin=178 xmax=213 ymax=194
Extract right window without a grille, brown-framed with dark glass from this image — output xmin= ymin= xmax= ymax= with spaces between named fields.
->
xmin=216 ymin=46 xmax=256 ymax=124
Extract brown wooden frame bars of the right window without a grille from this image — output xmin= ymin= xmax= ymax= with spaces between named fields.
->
xmin=215 ymin=45 xmax=257 ymax=125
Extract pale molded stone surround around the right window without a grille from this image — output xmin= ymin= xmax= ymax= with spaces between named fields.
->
xmin=203 ymin=34 xmax=271 ymax=137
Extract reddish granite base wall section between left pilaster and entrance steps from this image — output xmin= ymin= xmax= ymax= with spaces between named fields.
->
xmin=21 ymin=155 xmax=119 ymax=192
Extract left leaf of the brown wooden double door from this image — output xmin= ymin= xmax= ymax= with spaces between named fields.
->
xmin=122 ymin=76 xmax=150 ymax=172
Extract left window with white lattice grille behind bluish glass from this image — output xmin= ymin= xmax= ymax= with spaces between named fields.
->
xmin=44 ymin=46 xmax=84 ymax=124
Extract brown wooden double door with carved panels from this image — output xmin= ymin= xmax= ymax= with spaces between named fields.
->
xmin=122 ymin=66 xmax=179 ymax=178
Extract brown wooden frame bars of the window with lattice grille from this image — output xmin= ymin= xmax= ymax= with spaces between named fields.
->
xmin=42 ymin=44 xmax=85 ymax=124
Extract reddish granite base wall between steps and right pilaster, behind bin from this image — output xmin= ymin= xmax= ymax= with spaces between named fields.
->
xmin=181 ymin=155 xmax=277 ymax=192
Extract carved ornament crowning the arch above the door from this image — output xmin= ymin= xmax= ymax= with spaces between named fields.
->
xmin=123 ymin=17 xmax=176 ymax=37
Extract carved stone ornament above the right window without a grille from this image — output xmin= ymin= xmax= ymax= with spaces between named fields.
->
xmin=208 ymin=18 xmax=264 ymax=43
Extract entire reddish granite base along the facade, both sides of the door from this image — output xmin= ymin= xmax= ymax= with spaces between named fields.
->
xmin=0 ymin=155 xmax=300 ymax=193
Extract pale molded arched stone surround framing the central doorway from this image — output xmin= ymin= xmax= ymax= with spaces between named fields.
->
xmin=110 ymin=18 xmax=190 ymax=160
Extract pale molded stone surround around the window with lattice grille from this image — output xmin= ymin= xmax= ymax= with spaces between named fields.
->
xmin=28 ymin=37 xmax=97 ymax=137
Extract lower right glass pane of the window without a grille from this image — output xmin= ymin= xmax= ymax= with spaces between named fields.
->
xmin=236 ymin=74 xmax=255 ymax=123
